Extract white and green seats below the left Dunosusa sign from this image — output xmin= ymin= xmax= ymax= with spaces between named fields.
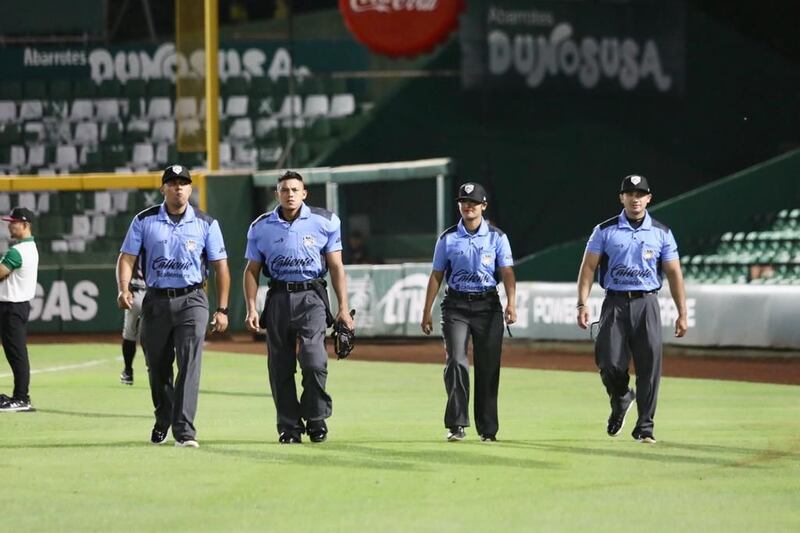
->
xmin=0 ymin=77 xmax=369 ymax=175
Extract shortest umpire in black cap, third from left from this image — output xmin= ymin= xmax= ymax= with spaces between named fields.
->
xmin=421 ymin=183 xmax=517 ymax=442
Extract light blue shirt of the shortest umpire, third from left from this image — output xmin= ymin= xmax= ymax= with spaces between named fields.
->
xmin=433 ymin=219 xmax=514 ymax=292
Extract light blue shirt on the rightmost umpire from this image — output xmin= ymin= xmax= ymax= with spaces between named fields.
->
xmin=586 ymin=209 xmax=679 ymax=291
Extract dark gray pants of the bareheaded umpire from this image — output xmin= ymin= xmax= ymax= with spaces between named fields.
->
xmin=261 ymin=289 xmax=333 ymax=433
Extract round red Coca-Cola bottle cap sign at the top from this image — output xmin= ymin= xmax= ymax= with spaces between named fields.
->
xmin=339 ymin=0 xmax=464 ymax=57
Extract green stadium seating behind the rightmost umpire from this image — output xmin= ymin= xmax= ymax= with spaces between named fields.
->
xmin=681 ymin=208 xmax=800 ymax=285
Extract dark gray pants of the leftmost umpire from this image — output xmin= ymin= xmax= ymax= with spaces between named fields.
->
xmin=141 ymin=289 xmax=208 ymax=440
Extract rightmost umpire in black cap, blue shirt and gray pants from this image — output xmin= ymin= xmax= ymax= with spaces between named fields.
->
xmin=577 ymin=175 xmax=688 ymax=444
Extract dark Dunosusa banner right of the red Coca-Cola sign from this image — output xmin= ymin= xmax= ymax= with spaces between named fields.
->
xmin=461 ymin=0 xmax=685 ymax=94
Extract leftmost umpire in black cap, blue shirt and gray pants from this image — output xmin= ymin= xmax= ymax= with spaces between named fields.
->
xmin=117 ymin=165 xmax=230 ymax=448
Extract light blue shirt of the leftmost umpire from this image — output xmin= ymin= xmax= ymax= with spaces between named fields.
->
xmin=120 ymin=203 xmax=228 ymax=289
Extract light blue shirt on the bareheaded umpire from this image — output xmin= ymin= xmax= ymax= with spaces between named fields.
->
xmin=245 ymin=203 xmax=342 ymax=281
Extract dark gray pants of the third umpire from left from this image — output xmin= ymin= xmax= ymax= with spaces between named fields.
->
xmin=442 ymin=295 xmax=503 ymax=435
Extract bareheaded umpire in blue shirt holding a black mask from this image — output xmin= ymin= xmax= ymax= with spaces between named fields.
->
xmin=244 ymin=171 xmax=354 ymax=444
